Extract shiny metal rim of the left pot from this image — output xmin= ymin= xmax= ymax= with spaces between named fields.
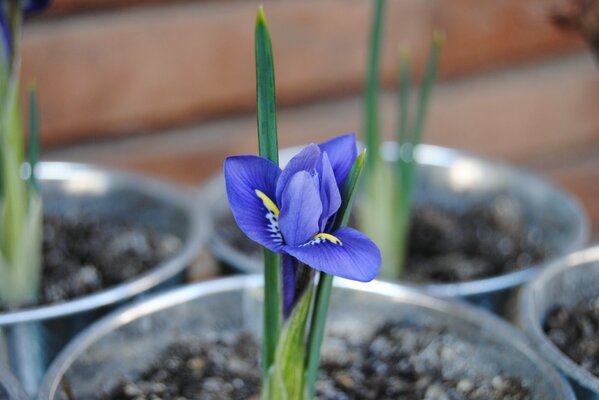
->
xmin=0 ymin=162 xmax=210 ymax=327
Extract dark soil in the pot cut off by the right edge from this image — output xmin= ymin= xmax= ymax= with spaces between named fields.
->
xmin=543 ymin=296 xmax=599 ymax=377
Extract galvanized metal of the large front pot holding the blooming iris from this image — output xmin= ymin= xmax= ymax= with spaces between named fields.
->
xmin=38 ymin=276 xmax=574 ymax=400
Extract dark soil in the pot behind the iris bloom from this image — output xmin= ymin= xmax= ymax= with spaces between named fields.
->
xmin=217 ymin=206 xmax=548 ymax=283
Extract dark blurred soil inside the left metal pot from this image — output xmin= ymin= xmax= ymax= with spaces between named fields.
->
xmin=3 ymin=213 xmax=181 ymax=310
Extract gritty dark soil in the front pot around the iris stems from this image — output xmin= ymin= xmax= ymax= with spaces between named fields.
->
xmin=106 ymin=323 xmax=531 ymax=400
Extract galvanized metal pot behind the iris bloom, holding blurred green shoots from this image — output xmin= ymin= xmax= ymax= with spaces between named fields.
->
xmin=207 ymin=143 xmax=589 ymax=313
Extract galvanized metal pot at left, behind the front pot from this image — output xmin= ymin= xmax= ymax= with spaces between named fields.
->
xmin=0 ymin=162 xmax=210 ymax=396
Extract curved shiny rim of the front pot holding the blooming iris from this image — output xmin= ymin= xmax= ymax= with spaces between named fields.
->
xmin=38 ymin=275 xmax=575 ymax=400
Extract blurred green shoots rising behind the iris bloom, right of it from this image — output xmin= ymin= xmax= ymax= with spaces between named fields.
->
xmin=359 ymin=0 xmax=444 ymax=279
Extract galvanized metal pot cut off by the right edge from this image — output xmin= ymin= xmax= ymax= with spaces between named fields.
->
xmin=519 ymin=246 xmax=599 ymax=400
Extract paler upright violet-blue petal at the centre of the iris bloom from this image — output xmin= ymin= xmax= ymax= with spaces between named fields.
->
xmin=279 ymin=171 xmax=322 ymax=246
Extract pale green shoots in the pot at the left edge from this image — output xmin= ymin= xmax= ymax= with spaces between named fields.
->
xmin=0 ymin=1 xmax=42 ymax=306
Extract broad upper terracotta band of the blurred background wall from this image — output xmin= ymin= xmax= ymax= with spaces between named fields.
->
xmin=23 ymin=0 xmax=579 ymax=146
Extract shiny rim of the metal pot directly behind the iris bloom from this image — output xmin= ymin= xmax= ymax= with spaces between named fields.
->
xmin=206 ymin=142 xmax=590 ymax=297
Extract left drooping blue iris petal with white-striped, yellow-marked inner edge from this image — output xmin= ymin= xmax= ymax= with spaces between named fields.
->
xmin=224 ymin=156 xmax=283 ymax=251
